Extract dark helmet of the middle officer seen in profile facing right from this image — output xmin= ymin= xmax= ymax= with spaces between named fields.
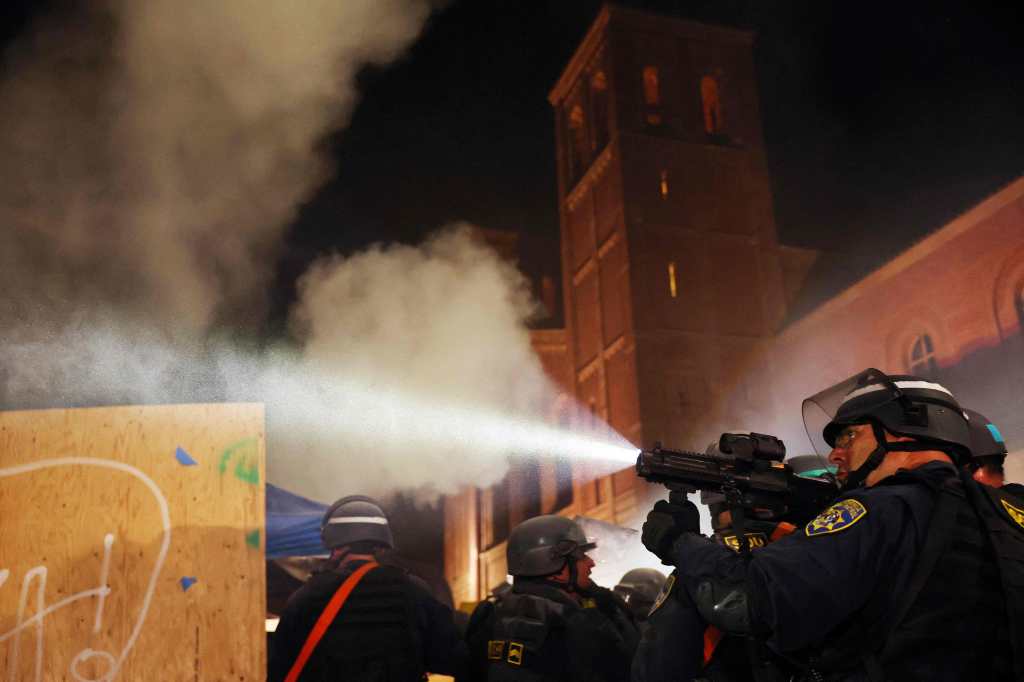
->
xmin=506 ymin=514 xmax=597 ymax=577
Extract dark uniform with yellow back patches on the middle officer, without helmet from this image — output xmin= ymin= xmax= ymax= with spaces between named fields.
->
xmin=460 ymin=580 xmax=637 ymax=682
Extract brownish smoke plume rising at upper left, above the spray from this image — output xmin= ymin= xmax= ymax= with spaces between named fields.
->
xmin=0 ymin=0 xmax=430 ymax=335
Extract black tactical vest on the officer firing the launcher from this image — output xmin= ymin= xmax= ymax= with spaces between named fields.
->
xmin=812 ymin=477 xmax=1024 ymax=682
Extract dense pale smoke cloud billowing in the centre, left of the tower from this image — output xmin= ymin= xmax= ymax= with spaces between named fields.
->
xmin=252 ymin=225 xmax=555 ymax=500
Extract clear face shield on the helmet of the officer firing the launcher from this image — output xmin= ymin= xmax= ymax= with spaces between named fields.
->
xmin=802 ymin=369 xmax=901 ymax=456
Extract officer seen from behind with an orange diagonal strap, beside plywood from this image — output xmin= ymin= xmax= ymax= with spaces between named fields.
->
xmin=268 ymin=496 xmax=468 ymax=682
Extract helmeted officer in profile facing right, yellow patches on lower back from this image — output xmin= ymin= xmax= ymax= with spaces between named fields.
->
xmin=467 ymin=515 xmax=636 ymax=682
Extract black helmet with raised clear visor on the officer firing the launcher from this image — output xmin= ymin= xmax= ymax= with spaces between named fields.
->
xmin=803 ymin=369 xmax=971 ymax=461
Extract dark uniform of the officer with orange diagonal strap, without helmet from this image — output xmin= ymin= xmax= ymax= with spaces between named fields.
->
xmin=268 ymin=561 xmax=467 ymax=682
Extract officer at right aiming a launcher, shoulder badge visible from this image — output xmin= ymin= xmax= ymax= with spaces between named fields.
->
xmin=643 ymin=370 xmax=1024 ymax=680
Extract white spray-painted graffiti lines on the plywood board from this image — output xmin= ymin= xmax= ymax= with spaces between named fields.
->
xmin=0 ymin=457 xmax=171 ymax=682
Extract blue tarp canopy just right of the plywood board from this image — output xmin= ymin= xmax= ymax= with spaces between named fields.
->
xmin=266 ymin=483 xmax=330 ymax=559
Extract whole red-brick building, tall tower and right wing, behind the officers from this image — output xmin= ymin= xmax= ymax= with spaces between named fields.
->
xmin=444 ymin=6 xmax=1024 ymax=601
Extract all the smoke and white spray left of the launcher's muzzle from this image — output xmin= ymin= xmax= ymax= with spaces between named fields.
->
xmin=0 ymin=0 xmax=634 ymax=500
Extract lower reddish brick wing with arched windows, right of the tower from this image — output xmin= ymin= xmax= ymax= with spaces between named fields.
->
xmin=756 ymin=178 xmax=1024 ymax=471
